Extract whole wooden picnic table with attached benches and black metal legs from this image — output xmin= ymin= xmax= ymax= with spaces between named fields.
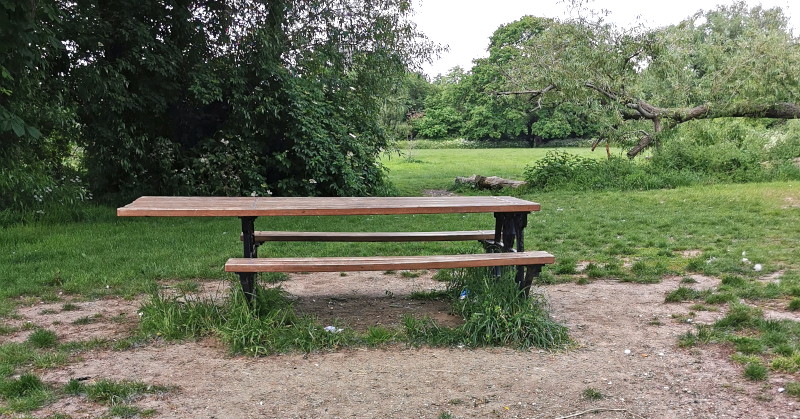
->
xmin=117 ymin=196 xmax=554 ymax=298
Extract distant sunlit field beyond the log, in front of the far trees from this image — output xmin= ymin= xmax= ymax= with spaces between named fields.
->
xmin=381 ymin=148 xmax=622 ymax=196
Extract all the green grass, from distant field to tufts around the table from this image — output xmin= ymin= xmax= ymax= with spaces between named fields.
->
xmin=0 ymin=149 xmax=800 ymax=413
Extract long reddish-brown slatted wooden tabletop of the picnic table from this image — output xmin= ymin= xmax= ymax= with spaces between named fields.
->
xmin=117 ymin=196 xmax=540 ymax=217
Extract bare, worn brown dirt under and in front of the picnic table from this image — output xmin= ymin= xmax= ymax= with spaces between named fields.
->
xmin=6 ymin=273 xmax=800 ymax=418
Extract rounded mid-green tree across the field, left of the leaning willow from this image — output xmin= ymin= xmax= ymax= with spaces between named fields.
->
xmin=415 ymin=16 xmax=591 ymax=145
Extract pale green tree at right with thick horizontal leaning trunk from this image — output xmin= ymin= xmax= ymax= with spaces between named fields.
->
xmin=500 ymin=2 xmax=800 ymax=158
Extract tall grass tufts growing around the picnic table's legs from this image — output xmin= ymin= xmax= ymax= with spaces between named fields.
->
xmin=140 ymin=270 xmax=570 ymax=355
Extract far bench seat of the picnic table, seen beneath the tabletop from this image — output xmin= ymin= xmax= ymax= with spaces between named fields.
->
xmin=245 ymin=230 xmax=494 ymax=243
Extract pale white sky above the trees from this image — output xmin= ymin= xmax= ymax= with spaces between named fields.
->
xmin=414 ymin=0 xmax=800 ymax=78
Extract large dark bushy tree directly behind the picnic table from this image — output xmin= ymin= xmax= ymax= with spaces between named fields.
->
xmin=61 ymin=0 xmax=435 ymax=199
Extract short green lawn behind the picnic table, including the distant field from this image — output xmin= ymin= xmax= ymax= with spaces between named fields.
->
xmin=0 ymin=149 xmax=800 ymax=311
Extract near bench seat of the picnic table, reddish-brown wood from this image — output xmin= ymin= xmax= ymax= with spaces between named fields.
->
xmin=225 ymin=251 xmax=555 ymax=272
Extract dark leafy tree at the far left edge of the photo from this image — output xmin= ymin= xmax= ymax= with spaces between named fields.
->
xmin=0 ymin=0 xmax=86 ymax=218
